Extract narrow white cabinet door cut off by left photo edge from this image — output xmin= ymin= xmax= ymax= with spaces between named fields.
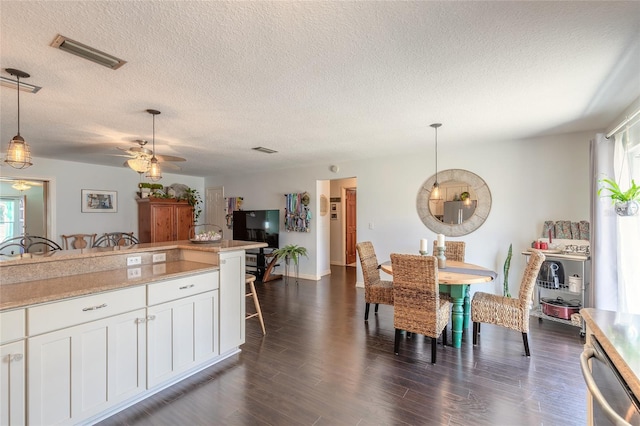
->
xmin=0 ymin=340 xmax=26 ymax=426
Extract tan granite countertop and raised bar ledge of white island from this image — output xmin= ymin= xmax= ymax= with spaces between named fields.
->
xmin=0 ymin=240 xmax=267 ymax=310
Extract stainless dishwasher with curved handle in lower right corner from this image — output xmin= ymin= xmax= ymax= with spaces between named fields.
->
xmin=580 ymin=335 xmax=640 ymax=426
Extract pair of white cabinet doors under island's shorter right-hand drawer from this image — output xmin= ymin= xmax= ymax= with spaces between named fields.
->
xmin=147 ymin=290 xmax=219 ymax=389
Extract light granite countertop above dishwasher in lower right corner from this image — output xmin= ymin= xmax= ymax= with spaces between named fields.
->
xmin=580 ymin=308 xmax=640 ymax=398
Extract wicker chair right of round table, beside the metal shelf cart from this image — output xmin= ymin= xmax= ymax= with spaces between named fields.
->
xmin=471 ymin=251 xmax=544 ymax=356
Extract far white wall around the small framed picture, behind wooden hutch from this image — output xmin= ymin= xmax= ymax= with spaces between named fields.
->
xmin=2 ymin=158 xmax=205 ymax=242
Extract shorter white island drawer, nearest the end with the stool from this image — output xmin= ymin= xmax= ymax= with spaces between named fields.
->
xmin=148 ymin=271 xmax=218 ymax=306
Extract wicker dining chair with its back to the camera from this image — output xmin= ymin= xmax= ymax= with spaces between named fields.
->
xmin=391 ymin=253 xmax=451 ymax=364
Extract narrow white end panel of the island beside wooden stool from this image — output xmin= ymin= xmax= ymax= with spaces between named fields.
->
xmin=220 ymin=250 xmax=245 ymax=354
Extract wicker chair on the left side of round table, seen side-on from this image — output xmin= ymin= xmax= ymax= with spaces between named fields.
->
xmin=356 ymin=241 xmax=393 ymax=321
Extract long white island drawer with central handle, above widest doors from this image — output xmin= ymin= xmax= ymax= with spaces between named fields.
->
xmin=27 ymin=286 xmax=145 ymax=336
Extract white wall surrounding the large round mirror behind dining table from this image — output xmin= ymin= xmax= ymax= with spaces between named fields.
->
xmin=205 ymin=133 xmax=593 ymax=294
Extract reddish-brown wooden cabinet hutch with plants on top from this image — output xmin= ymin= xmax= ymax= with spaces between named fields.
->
xmin=138 ymin=198 xmax=193 ymax=243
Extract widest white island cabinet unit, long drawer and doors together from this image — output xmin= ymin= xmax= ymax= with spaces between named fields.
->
xmin=27 ymin=287 xmax=146 ymax=425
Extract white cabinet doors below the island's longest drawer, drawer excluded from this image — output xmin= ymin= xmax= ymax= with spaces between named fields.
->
xmin=27 ymin=309 xmax=146 ymax=425
